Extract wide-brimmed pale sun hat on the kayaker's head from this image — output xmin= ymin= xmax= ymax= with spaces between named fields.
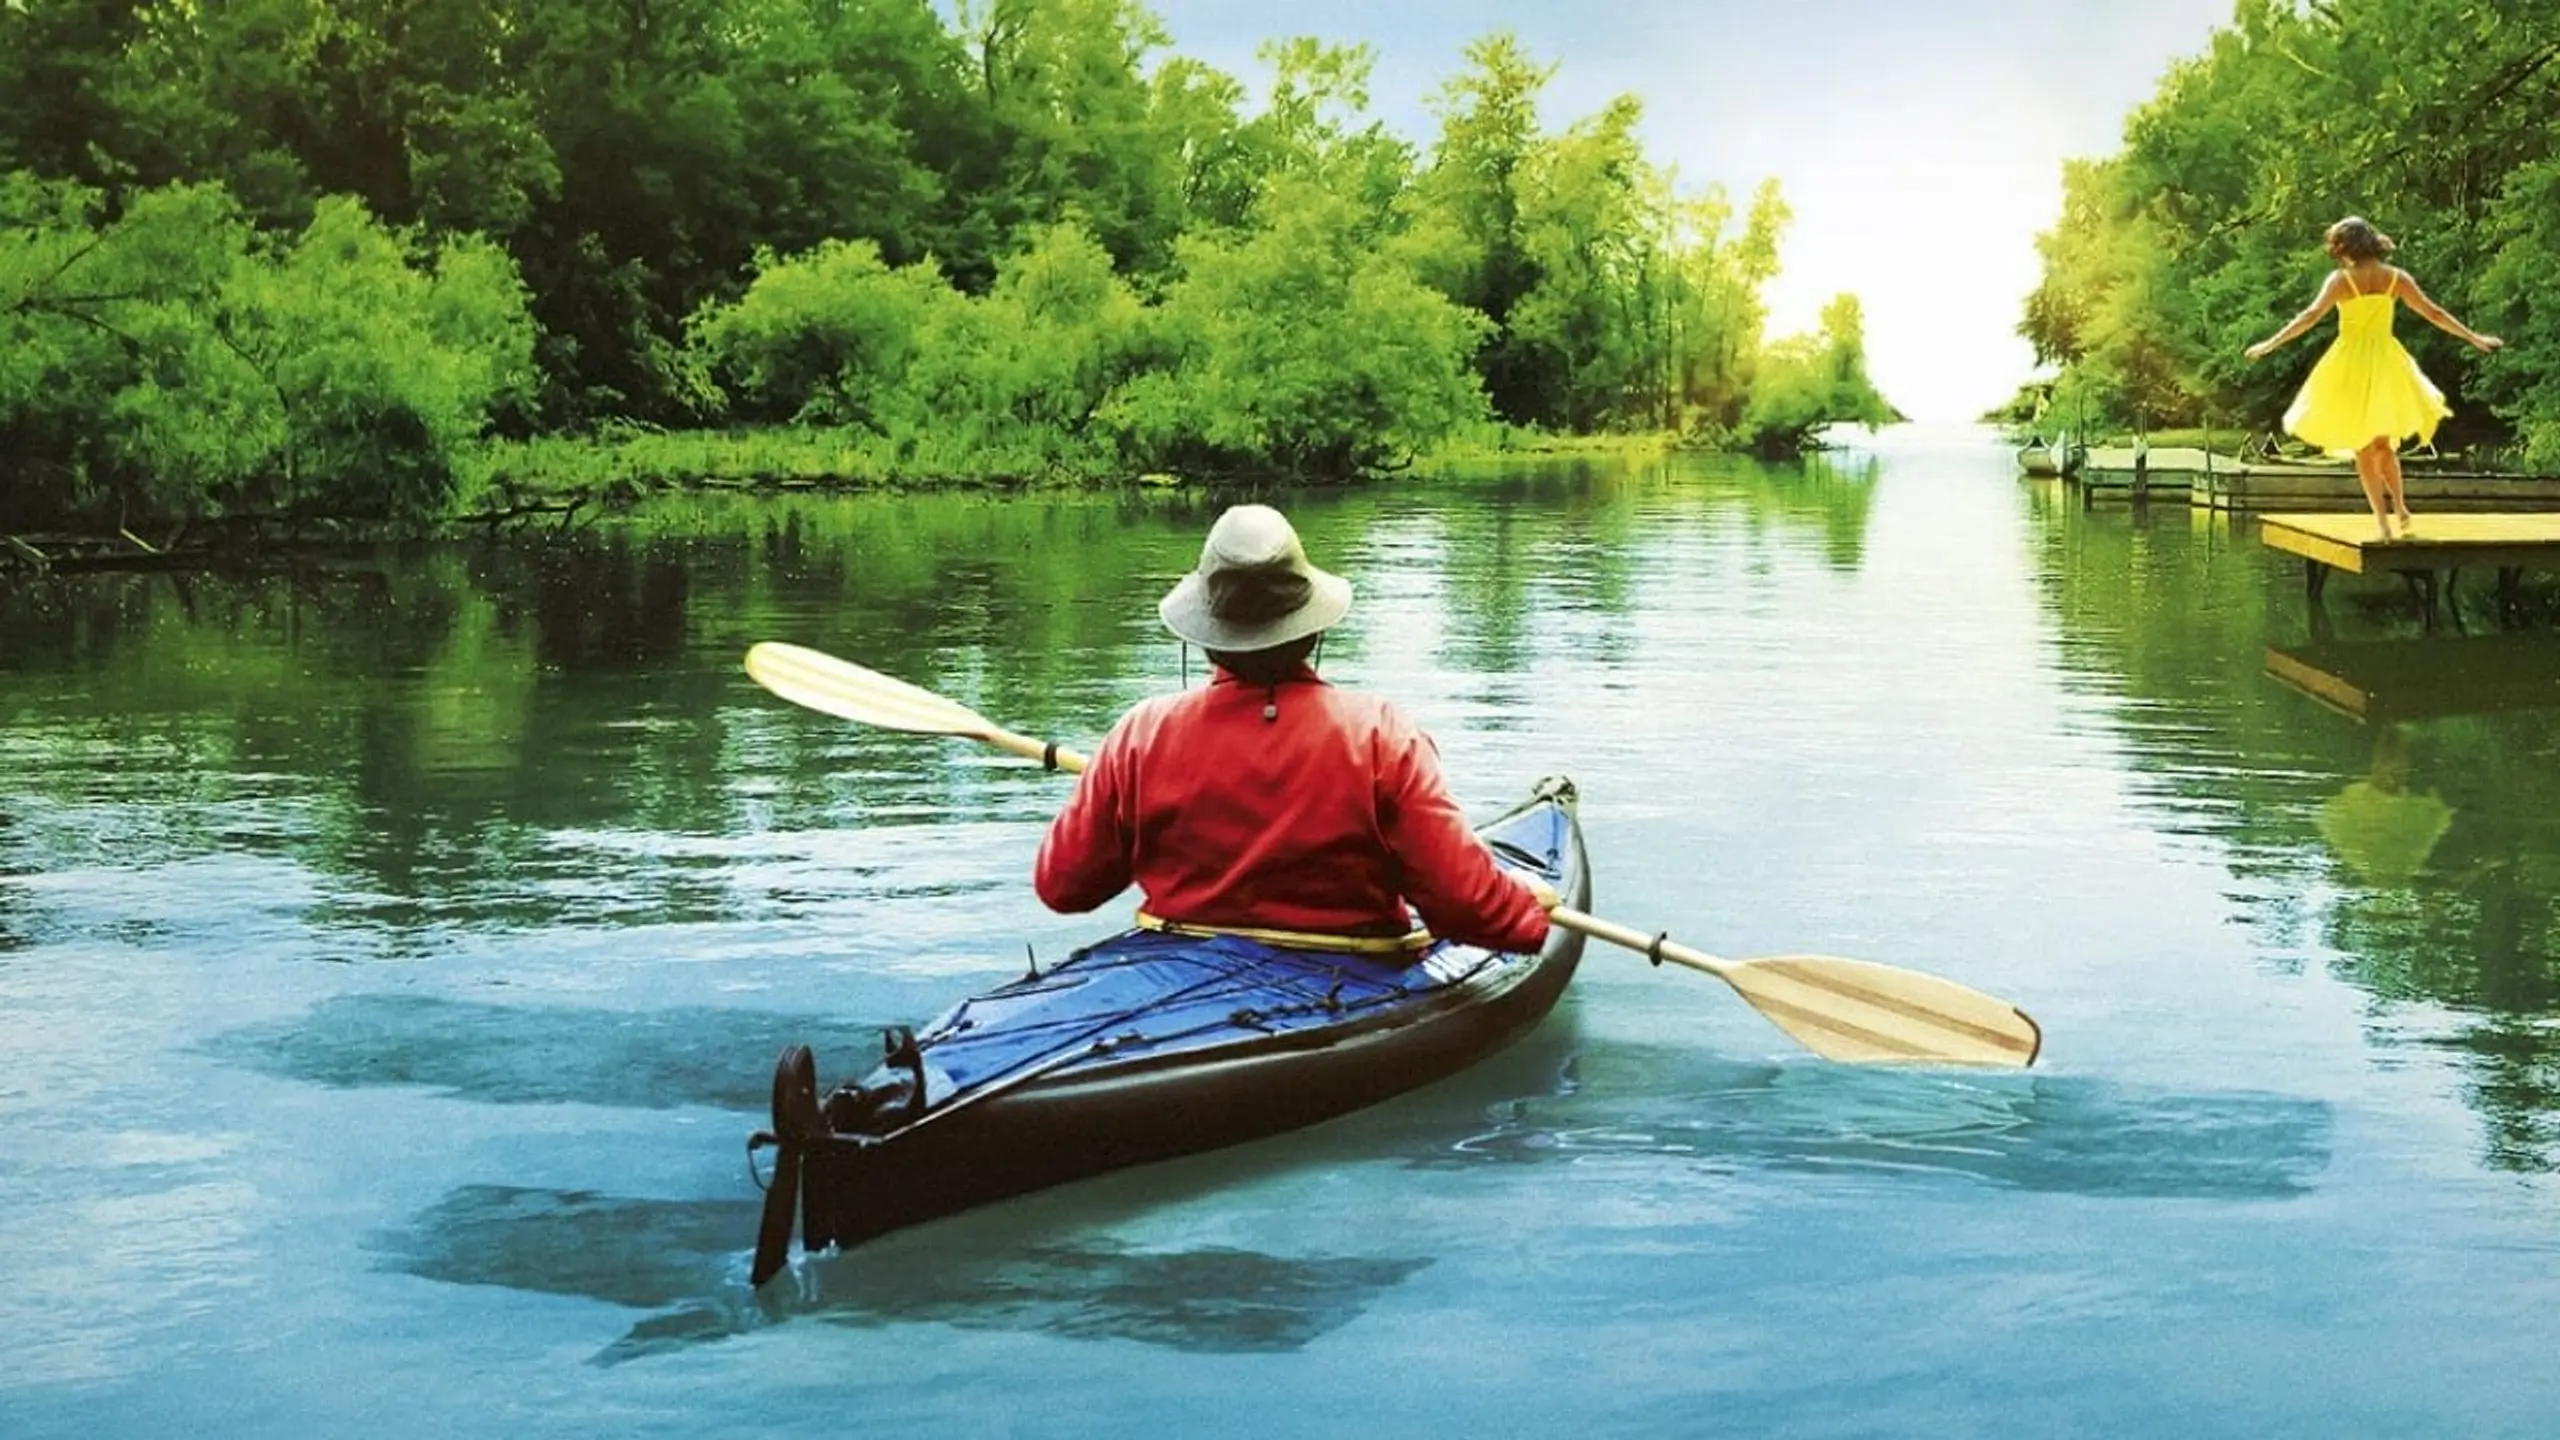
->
xmin=1155 ymin=505 xmax=1352 ymax=653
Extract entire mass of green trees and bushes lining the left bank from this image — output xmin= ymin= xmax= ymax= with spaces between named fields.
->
xmin=0 ymin=0 xmax=1884 ymax=523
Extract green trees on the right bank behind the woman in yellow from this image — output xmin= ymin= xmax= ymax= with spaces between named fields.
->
xmin=2020 ymin=0 xmax=2560 ymax=466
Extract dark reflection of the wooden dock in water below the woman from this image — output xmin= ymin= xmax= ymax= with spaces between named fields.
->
xmin=2266 ymin=630 xmax=2560 ymax=725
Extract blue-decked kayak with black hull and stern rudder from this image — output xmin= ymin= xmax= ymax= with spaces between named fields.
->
xmin=748 ymin=776 xmax=1590 ymax=1284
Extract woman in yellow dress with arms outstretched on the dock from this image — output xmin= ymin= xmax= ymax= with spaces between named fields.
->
xmin=2248 ymin=215 xmax=2506 ymax=541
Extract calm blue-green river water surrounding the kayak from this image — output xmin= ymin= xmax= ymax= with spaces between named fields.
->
xmin=0 ymin=430 xmax=2560 ymax=1437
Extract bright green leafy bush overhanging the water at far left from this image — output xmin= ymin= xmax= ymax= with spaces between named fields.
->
xmin=0 ymin=174 xmax=532 ymax=520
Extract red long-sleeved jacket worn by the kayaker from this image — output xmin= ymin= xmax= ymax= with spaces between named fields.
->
xmin=1032 ymin=666 xmax=1546 ymax=951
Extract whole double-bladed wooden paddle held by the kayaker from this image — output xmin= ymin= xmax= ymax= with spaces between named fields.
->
xmin=748 ymin=641 xmax=2043 ymax=1068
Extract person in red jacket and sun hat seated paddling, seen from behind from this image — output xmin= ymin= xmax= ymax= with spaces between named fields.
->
xmin=1032 ymin=505 xmax=1556 ymax=951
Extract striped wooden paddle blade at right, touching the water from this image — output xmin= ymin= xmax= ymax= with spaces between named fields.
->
xmin=1720 ymin=956 xmax=2045 ymax=1068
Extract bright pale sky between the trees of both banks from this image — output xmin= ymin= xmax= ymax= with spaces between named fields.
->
xmin=1149 ymin=0 xmax=2232 ymax=420
